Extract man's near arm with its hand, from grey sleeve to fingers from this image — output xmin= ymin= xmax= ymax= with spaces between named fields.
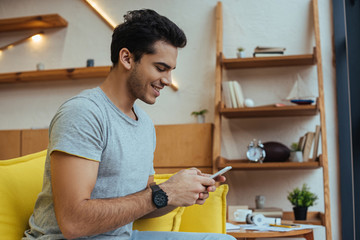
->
xmin=51 ymin=151 xmax=215 ymax=239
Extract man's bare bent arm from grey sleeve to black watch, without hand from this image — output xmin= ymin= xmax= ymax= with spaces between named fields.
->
xmin=51 ymin=151 xmax=156 ymax=239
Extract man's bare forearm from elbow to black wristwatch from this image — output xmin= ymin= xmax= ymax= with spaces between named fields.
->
xmin=56 ymin=188 xmax=156 ymax=239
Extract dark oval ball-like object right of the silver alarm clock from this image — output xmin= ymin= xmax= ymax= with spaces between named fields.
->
xmin=263 ymin=142 xmax=290 ymax=162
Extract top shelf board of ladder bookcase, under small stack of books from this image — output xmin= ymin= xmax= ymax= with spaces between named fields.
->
xmin=221 ymin=54 xmax=316 ymax=69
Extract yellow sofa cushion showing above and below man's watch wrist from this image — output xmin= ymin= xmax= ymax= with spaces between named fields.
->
xmin=133 ymin=174 xmax=185 ymax=232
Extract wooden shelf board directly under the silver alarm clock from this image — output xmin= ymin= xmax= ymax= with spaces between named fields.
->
xmin=217 ymin=158 xmax=321 ymax=170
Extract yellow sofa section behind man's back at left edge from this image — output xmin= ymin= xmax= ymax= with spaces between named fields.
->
xmin=0 ymin=150 xmax=46 ymax=240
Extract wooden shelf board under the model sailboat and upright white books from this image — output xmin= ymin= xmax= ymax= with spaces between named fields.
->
xmin=220 ymin=103 xmax=319 ymax=118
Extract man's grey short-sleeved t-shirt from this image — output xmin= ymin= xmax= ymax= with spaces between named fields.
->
xmin=24 ymin=87 xmax=156 ymax=240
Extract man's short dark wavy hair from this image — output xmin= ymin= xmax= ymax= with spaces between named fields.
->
xmin=111 ymin=9 xmax=186 ymax=66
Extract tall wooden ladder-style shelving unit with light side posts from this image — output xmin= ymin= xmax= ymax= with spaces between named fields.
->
xmin=213 ymin=0 xmax=331 ymax=240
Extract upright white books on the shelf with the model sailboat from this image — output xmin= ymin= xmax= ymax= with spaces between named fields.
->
xmin=222 ymin=81 xmax=245 ymax=108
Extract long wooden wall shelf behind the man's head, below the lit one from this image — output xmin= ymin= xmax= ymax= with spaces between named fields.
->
xmin=0 ymin=66 xmax=110 ymax=84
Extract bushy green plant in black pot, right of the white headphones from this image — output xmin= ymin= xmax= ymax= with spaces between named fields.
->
xmin=287 ymin=183 xmax=318 ymax=220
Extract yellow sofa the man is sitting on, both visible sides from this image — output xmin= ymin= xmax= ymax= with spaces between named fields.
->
xmin=0 ymin=150 xmax=228 ymax=240
